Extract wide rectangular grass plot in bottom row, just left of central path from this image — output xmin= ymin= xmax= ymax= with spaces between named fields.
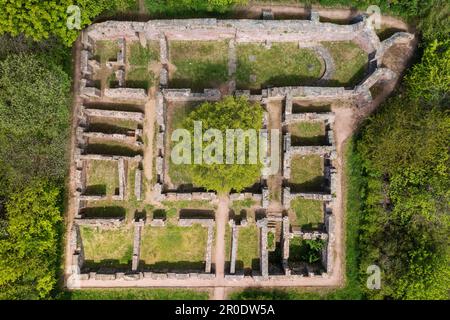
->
xmin=141 ymin=224 xmax=208 ymax=270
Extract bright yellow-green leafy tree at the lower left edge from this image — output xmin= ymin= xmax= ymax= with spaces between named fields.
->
xmin=0 ymin=181 xmax=62 ymax=299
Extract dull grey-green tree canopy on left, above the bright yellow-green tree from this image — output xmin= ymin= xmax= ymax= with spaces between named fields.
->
xmin=0 ymin=54 xmax=70 ymax=194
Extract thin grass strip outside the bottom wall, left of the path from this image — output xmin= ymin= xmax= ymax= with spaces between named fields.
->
xmin=61 ymin=289 xmax=209 ymax=300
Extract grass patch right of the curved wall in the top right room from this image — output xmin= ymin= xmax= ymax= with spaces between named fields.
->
xmin=322 ymin=41 xmax=368 ymax=86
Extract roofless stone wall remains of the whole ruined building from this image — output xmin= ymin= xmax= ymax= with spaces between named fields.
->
xmin=70 ymin=10 xmax=414 ymax=283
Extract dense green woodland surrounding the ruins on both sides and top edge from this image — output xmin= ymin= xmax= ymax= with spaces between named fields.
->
xmin=0 ymin=0 xmax=450 ymax=299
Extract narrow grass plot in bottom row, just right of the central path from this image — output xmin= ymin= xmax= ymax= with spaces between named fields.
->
xmin=236 ymin=224 xmax=259 ymax=271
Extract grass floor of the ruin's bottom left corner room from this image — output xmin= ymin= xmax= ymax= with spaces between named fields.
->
xmin=80 ymin=226 xmax=133 ymax=268
